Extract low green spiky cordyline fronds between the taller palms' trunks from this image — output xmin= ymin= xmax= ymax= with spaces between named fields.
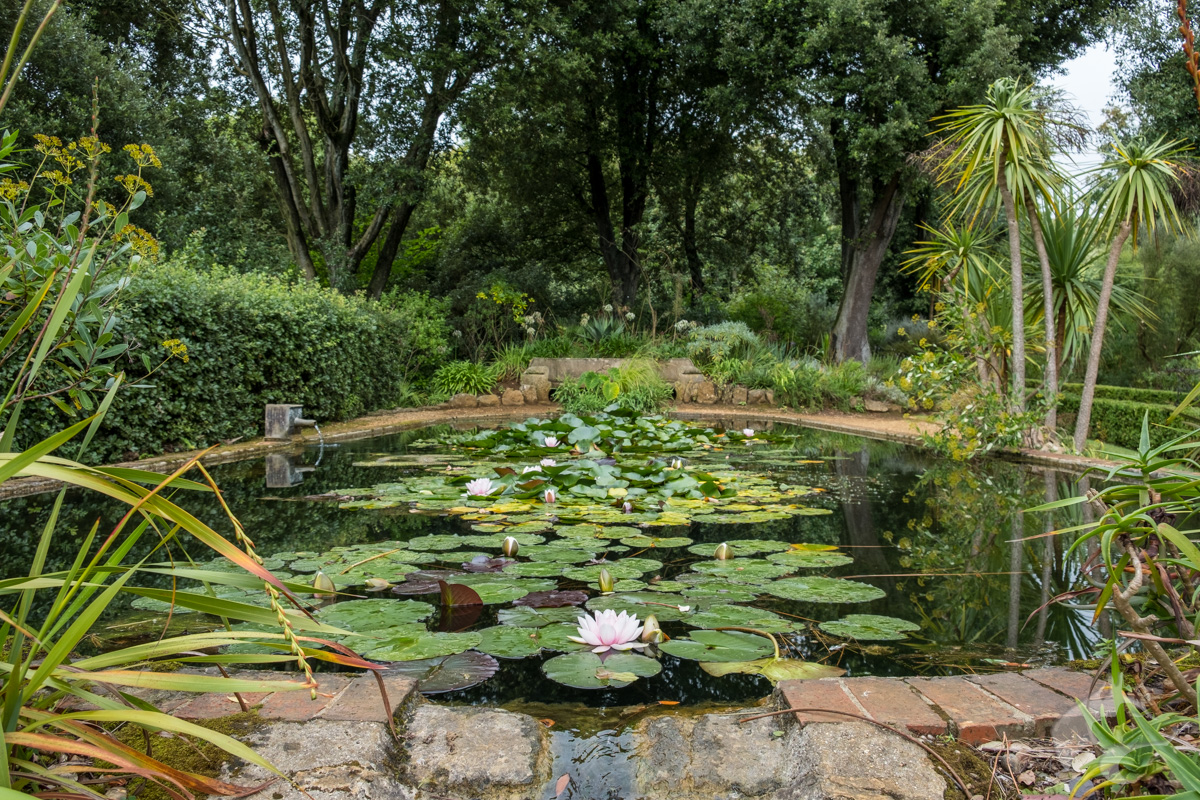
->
xmin=1025 ymin=198 xmax=1158 ymax=375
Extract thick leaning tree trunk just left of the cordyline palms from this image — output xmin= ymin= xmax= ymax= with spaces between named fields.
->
xmin=832 ymin=174 xmax=904 ymax=363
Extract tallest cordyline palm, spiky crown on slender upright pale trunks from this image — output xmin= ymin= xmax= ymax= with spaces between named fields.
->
xmin=935 ymin=78 xmax=1068 ymax=427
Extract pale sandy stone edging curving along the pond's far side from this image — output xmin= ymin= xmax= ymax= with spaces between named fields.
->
xmin=0 ymin=403 xmax=1118 ymax=500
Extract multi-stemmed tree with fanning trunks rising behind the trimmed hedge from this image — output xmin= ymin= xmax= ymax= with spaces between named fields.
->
xmin=223 ymin=0 xmax=522 ymax=297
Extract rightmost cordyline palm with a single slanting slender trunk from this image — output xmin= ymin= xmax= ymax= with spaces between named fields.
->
xmin=1075 ymin=137 xmax=1190 ymax=452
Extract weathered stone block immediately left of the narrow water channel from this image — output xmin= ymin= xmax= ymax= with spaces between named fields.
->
xmin=402 ymin=704 xmax=551 ymax=800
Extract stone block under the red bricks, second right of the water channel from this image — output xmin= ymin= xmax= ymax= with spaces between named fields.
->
xmin=774 ymin=722 xmax=946 ymax=800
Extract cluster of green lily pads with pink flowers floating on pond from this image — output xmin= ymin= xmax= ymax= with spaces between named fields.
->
xmin=131 ymin=414 xmax=916 ymax=693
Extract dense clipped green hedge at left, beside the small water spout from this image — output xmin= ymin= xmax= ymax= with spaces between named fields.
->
xmin=19 ymin=264 xmax=444 ymax=463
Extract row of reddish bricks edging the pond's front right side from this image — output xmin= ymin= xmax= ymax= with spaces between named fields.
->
xmin=779 ymin=668 xmax=1111 ymax=745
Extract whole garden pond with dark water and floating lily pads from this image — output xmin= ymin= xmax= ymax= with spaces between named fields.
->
xmin=0 ymin=417 xmax=1102 ymax=708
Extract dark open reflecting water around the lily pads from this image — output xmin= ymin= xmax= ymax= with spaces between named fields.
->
xmin=0 ymin=420 xmax=1106 ymax=690
